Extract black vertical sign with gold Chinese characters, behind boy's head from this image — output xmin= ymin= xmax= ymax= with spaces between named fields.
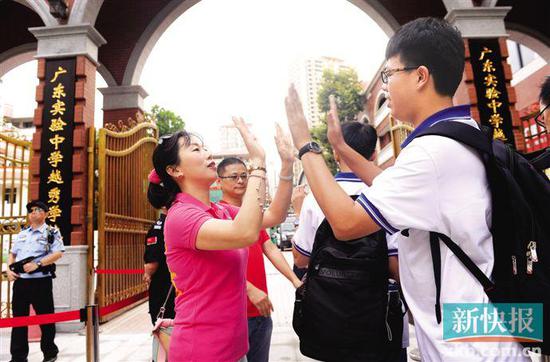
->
xmin=468 ymin=38 xmax=515 ymax=147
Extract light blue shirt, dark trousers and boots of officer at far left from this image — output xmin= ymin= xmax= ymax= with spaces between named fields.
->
xmin=10 ymin=224 xmax=65 ymax=362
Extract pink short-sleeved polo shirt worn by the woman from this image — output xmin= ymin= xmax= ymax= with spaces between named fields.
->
xmin=164 ymin=193 xmax=248 ymax=361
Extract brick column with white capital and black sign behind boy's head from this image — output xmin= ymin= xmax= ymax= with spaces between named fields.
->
xmin=445 ymin=6 xmax=525 ymax=151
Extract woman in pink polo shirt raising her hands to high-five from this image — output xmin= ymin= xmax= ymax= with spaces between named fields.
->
xmin=149 ymin=118 xmax=266 ymax=362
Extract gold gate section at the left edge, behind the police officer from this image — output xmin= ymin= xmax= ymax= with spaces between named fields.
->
xmin=0 ymin=134 xmax=33 ymax=318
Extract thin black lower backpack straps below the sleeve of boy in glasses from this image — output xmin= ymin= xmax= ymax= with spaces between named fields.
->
xmin=430 ymin=231 xmax=495 ymax=324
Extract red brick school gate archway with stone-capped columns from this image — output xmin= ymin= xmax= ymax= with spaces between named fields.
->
xmin=0 ymin=0 xmax=550 ymax=328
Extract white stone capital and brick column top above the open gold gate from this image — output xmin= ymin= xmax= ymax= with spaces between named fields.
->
xmin=99 ymin=85 xmax=148 ymax=128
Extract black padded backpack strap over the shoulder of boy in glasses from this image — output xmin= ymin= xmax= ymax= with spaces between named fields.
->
xmin=416 ymin=121 xmax=493 ymax=155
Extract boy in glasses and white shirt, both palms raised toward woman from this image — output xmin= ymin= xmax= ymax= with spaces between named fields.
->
xmin=285 ymin=18 xmax=528 ymax=361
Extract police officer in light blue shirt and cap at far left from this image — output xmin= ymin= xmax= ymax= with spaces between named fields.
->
xmin=7 ymin=201 xmax=65 ymax=362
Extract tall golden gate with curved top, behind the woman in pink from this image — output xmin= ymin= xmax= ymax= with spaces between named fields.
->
xmin=96 ymin=122 xmax=158 ymax=322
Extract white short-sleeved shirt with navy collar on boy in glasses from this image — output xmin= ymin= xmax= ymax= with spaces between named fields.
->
xmin=357 ymin=106 xmax=529 ymax=362
